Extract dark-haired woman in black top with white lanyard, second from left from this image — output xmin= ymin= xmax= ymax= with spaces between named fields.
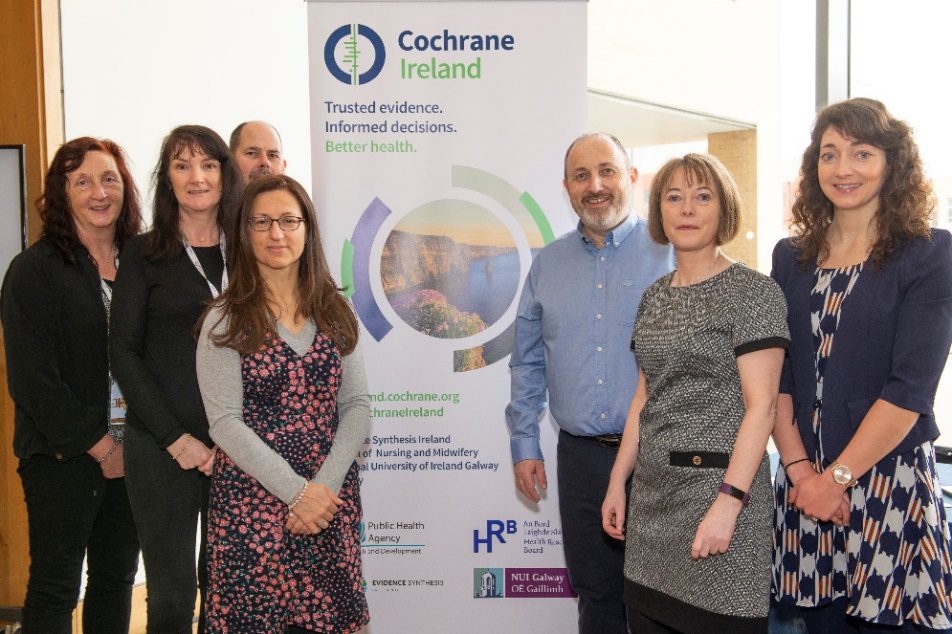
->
xmin=110 ymin=125 xmax=241 ymax=634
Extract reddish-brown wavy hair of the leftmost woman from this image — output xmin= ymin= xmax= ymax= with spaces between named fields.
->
xmin=36 ymin=136 xmax=142 ymax=262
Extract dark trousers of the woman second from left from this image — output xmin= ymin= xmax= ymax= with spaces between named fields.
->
xmin=125 ymin=427 xmax=209 ymax=634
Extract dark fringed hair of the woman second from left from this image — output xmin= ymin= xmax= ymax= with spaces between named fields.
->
xmin=146 ymin=125 xmax=242 ymax=259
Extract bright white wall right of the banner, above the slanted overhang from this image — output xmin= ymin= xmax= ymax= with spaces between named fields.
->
xmin=588 ymin=0 xmax=814 ymax=270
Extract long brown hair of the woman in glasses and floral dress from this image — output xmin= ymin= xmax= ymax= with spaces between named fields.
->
xmin=206 ymin=174 xmax=359 ymax=355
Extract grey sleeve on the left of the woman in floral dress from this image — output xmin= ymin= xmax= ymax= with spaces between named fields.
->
xmin=195 ymin=307 xmax=306 ymax=504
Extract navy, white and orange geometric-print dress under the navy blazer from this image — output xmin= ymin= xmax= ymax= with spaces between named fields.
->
xmin=773 ymin=263 xmax=952 ymax=630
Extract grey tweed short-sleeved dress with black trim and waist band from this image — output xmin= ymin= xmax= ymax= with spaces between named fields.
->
xmin=624 ymin=264 xmax=789 ymax=633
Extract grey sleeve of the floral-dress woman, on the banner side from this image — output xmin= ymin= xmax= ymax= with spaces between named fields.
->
xmin=313 ymin=344 xmax=370 ymax=493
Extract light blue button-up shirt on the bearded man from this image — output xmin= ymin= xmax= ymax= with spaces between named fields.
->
xmin=506 ymin=216 xmax=674 ymax=462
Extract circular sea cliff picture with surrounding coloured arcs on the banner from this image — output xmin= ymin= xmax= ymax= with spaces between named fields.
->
xmin=341 ymin=165 xmax=554 ymax=372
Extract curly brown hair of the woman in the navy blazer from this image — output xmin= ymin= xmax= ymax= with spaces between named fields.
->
xmin=792 ymin=97 xmax=935 ymax=267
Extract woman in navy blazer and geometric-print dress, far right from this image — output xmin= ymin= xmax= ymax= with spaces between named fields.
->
xmin=772 ymin=99 xmax=952 ymax=632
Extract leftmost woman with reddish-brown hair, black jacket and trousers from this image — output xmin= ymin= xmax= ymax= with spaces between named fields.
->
xmin=0 ymin=137 xmax=142 ymax=634
